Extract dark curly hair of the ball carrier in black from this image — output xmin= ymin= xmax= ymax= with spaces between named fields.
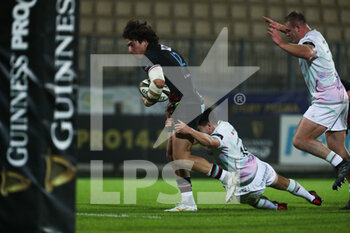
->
xmin=123 ymin=19 xmax=159 ymax=44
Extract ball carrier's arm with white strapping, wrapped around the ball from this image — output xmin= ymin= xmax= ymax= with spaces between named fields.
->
xmin=142 ymin=65 xmax=165 ymax=107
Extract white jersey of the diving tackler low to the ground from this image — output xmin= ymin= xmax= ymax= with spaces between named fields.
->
xmin=210 ymin=121 xmax=257 ymax=186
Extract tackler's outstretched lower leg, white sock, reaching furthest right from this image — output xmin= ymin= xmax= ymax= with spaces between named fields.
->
xmin=270 ymin=173 xmax=322 ymax=205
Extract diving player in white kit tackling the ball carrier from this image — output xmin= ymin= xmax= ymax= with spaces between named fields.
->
xmin=175 ymin=111 xmax=322 ymax=210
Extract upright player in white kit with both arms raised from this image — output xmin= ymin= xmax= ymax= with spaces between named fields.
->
xmin=264 ymin=11 xmax=350 ymax=206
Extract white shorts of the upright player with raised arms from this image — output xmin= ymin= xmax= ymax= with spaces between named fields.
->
xmin=304 ymin=102 xmax=349 ymax=131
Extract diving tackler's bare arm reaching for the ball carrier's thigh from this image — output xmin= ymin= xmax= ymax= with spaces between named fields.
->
xmin=175 ymin=120 xmax=220 ymax=147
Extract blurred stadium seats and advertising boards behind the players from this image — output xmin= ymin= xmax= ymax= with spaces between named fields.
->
xmin=78 ymin=0 xmax=350 ymax=177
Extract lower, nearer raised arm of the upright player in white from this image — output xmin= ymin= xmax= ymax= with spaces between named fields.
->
xmin=268 ymin=27 xmax=317 ymax=61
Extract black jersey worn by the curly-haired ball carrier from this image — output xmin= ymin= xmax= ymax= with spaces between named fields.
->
xmin=143 ymin=44 xmax=201 ymax=103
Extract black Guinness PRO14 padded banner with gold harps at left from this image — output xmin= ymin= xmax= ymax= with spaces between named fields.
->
xmin=0 ymin=0 xmax=79 ymax=233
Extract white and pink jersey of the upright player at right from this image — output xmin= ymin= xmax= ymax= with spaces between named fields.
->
xmin=298 ymin=29 xmax=348 ymax=103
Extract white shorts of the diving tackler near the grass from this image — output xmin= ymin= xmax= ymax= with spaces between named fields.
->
xmin=235 ymin=158 xmax=277 ymax=204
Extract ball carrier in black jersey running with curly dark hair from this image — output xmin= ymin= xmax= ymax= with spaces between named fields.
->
xmin=123 ymin=20 xmax=234 ymax=212
